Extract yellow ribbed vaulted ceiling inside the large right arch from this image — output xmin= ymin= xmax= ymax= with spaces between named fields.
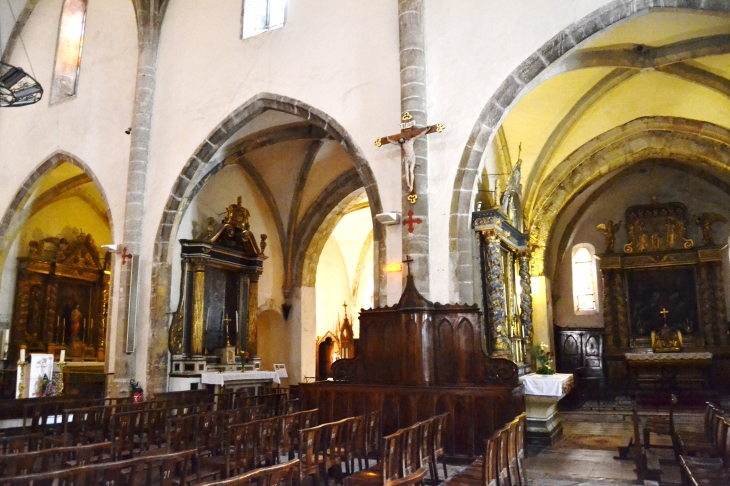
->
xmin=480 ymin=11 xmax=730 ymax=218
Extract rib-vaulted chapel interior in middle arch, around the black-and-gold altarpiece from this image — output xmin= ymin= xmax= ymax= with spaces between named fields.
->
xmin=161 ymin=98 xmax=384 ymax=389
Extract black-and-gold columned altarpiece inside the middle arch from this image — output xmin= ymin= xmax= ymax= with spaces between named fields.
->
xmin=168 ymin=197 xmax=267 ymax=376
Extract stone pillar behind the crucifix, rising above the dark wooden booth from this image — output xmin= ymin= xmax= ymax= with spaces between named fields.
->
xmin=398 ymin=0 xmax=430 ymax=299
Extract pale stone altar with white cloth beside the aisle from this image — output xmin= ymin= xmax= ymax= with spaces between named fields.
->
xmin=520 ymin=373 xmax=575 ymax=445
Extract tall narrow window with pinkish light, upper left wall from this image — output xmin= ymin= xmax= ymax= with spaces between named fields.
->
xmin=50 ymin=0 xmax=88 ymax=105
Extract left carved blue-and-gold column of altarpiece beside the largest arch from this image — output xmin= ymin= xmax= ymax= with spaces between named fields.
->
xmin=483 ymin=229 xmax=512 ymax=359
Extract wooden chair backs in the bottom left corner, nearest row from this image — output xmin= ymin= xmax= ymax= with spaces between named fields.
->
xmin=0 ymin=450 xmax=195 ymax=486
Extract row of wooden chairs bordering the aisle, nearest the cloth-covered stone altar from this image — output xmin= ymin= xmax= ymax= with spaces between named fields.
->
xmin=449 ymin=413 xmax=528 ymax=486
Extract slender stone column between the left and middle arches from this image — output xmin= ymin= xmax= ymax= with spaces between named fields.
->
xmin=107 ymin=0 xmax=168 ymax=396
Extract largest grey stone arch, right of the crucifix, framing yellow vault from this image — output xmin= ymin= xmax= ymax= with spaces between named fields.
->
xmin=449 ymin=0 xmax=730 ymax=302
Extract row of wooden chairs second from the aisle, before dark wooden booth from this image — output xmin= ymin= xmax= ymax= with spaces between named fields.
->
xmin=342 ymin=413 xmax=448 ymax=486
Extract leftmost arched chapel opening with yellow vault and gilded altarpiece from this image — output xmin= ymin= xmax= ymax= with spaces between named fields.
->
xmin=0 ymin=156 xmax=112 ymax=396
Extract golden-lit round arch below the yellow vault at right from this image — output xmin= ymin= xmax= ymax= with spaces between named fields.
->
xmin=529 ymin=117 xmax=730 ymax=276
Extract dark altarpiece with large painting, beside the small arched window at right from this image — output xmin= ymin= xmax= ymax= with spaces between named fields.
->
xmin=598 ymin=198 xmax=728 ymax=386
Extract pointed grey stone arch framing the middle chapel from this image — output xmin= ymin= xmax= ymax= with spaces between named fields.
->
xmin=147 ymin=93 xmax=386 ymax=391
